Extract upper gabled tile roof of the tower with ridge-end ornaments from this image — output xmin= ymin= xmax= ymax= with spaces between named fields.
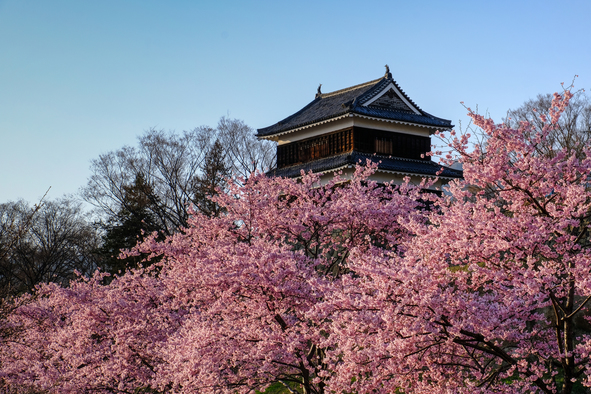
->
xmin=257 ymin=70 xmax=453 ymax=137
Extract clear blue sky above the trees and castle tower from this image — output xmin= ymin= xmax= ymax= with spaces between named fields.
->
xmin=0 ymin=0 xmax=591 ymax=203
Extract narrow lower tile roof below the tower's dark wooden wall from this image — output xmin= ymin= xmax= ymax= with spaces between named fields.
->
xmin=267 ymin=152 xmax=463 ymax=178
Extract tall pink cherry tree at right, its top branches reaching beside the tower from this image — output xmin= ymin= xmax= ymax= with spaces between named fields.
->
xmin=329 ymin=86 xmax=591 ymax=393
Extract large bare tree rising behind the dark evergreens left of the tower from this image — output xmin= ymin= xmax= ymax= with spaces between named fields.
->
xmin=82 ymin=127 xmax=213 ymax=235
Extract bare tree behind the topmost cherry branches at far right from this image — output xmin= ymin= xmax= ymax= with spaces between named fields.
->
xmin=504 ymin=91 xmax=591 ymax=157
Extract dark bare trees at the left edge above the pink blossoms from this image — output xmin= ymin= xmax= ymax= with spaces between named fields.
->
xmin=0 ymin=198 xmax=100 ymax=296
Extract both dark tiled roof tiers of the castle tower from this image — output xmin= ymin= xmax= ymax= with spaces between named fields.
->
xmin=257 ymin=66 xmax=462 ymax=179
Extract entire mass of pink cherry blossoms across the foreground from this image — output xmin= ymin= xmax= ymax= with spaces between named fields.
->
xmin=0 ymin=87 xmax=591 ymax=394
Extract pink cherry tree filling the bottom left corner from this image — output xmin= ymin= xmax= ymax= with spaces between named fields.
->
xmin=0 ymin=271 xmax=178 ymax=393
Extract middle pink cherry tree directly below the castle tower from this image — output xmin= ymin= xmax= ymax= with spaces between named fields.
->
xmin=133 ymin=167 xmax=420 ymax=393
